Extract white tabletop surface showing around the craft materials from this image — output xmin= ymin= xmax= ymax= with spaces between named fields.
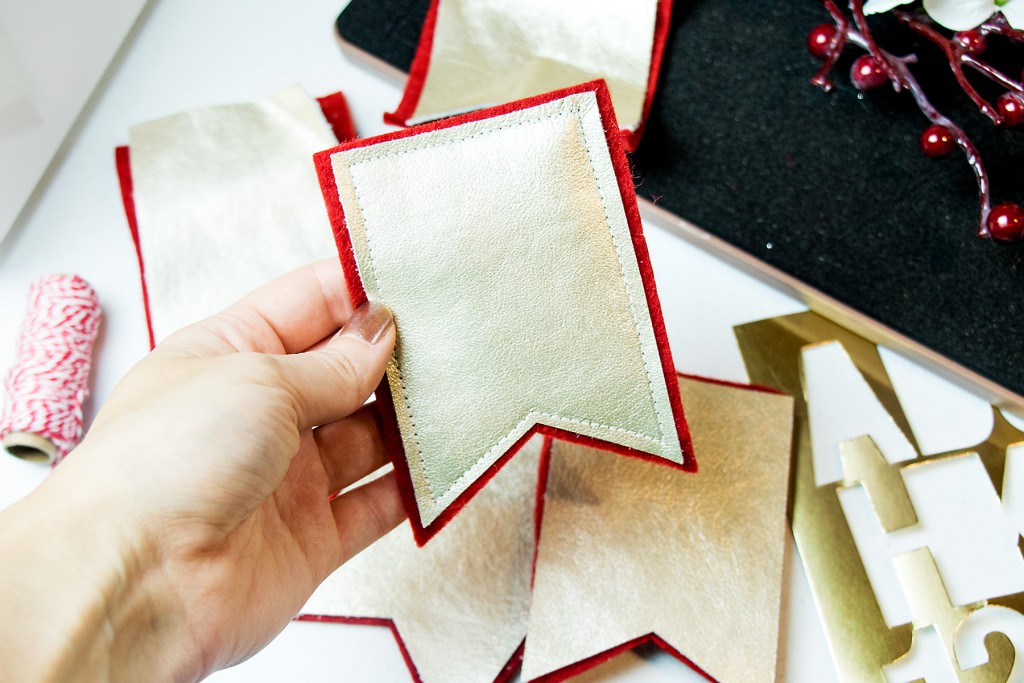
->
xmin=0 ymin=0 xmax=1003 ymax=683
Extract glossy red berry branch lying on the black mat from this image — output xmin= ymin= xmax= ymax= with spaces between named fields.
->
xmin=807 ymin=0 xmax=1024 ymax=243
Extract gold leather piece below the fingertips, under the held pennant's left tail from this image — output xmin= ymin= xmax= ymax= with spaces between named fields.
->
xmin=302 ymin=436 xmax=543 ymax=683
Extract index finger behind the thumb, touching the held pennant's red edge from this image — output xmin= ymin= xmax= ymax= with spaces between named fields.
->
xmin=163 ymin=258 xmax=353 ymax=354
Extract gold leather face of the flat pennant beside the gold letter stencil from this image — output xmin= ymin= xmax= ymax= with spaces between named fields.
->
xmin=523 ymin=379 xmax=793 ymax=683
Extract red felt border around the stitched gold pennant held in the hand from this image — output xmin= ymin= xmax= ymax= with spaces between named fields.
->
xmin=314 ymin=81 xmax=696 ymax=546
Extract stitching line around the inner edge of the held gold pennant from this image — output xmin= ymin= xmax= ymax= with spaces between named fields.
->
xmin=349 ymin=105 xmax=666 ymax=506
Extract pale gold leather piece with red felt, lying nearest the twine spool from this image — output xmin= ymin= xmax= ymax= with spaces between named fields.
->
xmin=116 ymin=86 xmax=355 ymax=346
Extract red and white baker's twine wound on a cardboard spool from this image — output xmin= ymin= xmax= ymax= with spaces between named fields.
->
xmin=0 ymin=275 xmax=100 ymax=462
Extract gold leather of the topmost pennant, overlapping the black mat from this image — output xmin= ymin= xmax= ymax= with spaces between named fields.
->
xmin=410 ymin=0 xmax=657 ymax=130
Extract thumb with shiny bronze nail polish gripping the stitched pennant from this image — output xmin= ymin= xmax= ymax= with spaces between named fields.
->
xmin=279 ymin=301 xmax=395 ymax=429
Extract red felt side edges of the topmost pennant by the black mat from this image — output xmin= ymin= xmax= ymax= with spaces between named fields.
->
xmin=384 ymin=0 xmax=672 ymax=152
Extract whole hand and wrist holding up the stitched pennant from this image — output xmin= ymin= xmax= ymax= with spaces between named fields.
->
xmin=0 ymin=261 xmax=403 ymax=681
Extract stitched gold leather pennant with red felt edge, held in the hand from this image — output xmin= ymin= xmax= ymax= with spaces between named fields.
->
xmin=315 ymin=81 xmax=695 ymax=543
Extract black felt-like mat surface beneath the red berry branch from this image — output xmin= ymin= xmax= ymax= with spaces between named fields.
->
xmin=338 ymin=0 xmax=1024 ymax=394
